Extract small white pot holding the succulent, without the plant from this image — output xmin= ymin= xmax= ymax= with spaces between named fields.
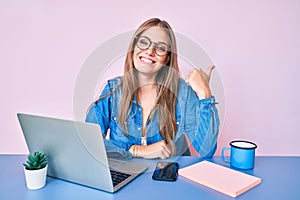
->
xmin=24 ymin=165 xmax=48 ymax=190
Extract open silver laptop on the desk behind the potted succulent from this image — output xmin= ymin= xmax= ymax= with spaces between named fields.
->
xmin=17 ymin=113 xmax=147 ymax=193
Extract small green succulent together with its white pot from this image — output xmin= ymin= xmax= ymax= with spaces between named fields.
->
xmin=23 ymin=151 xmax=48 ymax=190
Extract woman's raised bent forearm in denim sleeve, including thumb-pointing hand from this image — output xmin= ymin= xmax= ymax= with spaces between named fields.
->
xmin=186 ymin=66 xmax=220 ymax=157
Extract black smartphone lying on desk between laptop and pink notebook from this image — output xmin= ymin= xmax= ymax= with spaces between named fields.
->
xmin=152 ymin=162 xmax=179 ymax=181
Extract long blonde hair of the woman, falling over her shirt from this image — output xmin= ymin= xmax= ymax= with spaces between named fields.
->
xmin=118 ymin=18 xmax=179 ymax=143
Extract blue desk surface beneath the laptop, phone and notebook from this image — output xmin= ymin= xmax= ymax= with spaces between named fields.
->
xmin=0 ymin=155 xmax=300 ymax=200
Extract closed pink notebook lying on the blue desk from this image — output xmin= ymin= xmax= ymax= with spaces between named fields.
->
xmin=178 ymin=161 xmax=261 ymax=197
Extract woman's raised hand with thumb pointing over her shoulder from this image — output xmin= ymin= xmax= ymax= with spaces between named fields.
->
xmin=185 ymin=65 xmax=215 ymax=99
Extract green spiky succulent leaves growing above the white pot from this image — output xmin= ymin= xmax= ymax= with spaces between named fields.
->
xmin=23 ymin=151 xmax=47 ymax=170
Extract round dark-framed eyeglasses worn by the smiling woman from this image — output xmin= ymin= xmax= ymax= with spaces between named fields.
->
xmin=136 ymin=36 xmax=169 ymax=56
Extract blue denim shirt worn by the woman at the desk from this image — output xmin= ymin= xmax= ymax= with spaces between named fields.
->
xmin=86 ymin=77 xmax=219 ymax=158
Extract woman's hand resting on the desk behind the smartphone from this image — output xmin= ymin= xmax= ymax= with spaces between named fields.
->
xmin=135 ymin=140 xmax=172 ymax=159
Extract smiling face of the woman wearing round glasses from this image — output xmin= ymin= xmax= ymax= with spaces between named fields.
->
xmin=133 ymin=26 xmax=169 ymax=81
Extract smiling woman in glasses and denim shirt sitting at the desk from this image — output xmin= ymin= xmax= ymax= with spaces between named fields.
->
xmin=86 ymin=18 xmax=219 ymax=159
